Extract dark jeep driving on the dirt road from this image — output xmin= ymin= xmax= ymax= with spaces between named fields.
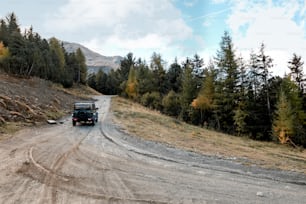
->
xmin=72 ymin=101 xmax=98 ymax=126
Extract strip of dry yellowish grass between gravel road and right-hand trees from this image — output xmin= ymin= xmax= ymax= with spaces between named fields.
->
xmin=112 ymin=97 xmax=306 ymax=174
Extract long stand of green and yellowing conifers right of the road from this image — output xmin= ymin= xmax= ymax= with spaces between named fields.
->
xmin=88 ymin=32 xmax=306 ymax=147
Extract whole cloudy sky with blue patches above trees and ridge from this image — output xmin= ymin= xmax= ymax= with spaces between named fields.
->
xmin=0 ymin=0 xmax=306 ymax=76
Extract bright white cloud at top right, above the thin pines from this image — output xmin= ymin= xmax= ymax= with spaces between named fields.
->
xmin=227 ymin=1 xmax=306 ymax=75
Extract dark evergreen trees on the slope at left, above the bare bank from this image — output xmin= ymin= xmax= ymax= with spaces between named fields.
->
xmin=0 ymin=13 xmax=87 ymax=87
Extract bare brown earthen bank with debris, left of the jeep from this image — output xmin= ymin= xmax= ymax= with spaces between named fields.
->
xmin=0 ymin=73 xmax=98 ymax=135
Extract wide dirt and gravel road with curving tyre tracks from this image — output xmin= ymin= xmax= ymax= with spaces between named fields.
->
xmin=0 ymin=96 xmax=306 ymax=204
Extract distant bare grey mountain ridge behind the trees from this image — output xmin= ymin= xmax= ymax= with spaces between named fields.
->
xmin=62 ymin=41 xmax=123 ymax=73
